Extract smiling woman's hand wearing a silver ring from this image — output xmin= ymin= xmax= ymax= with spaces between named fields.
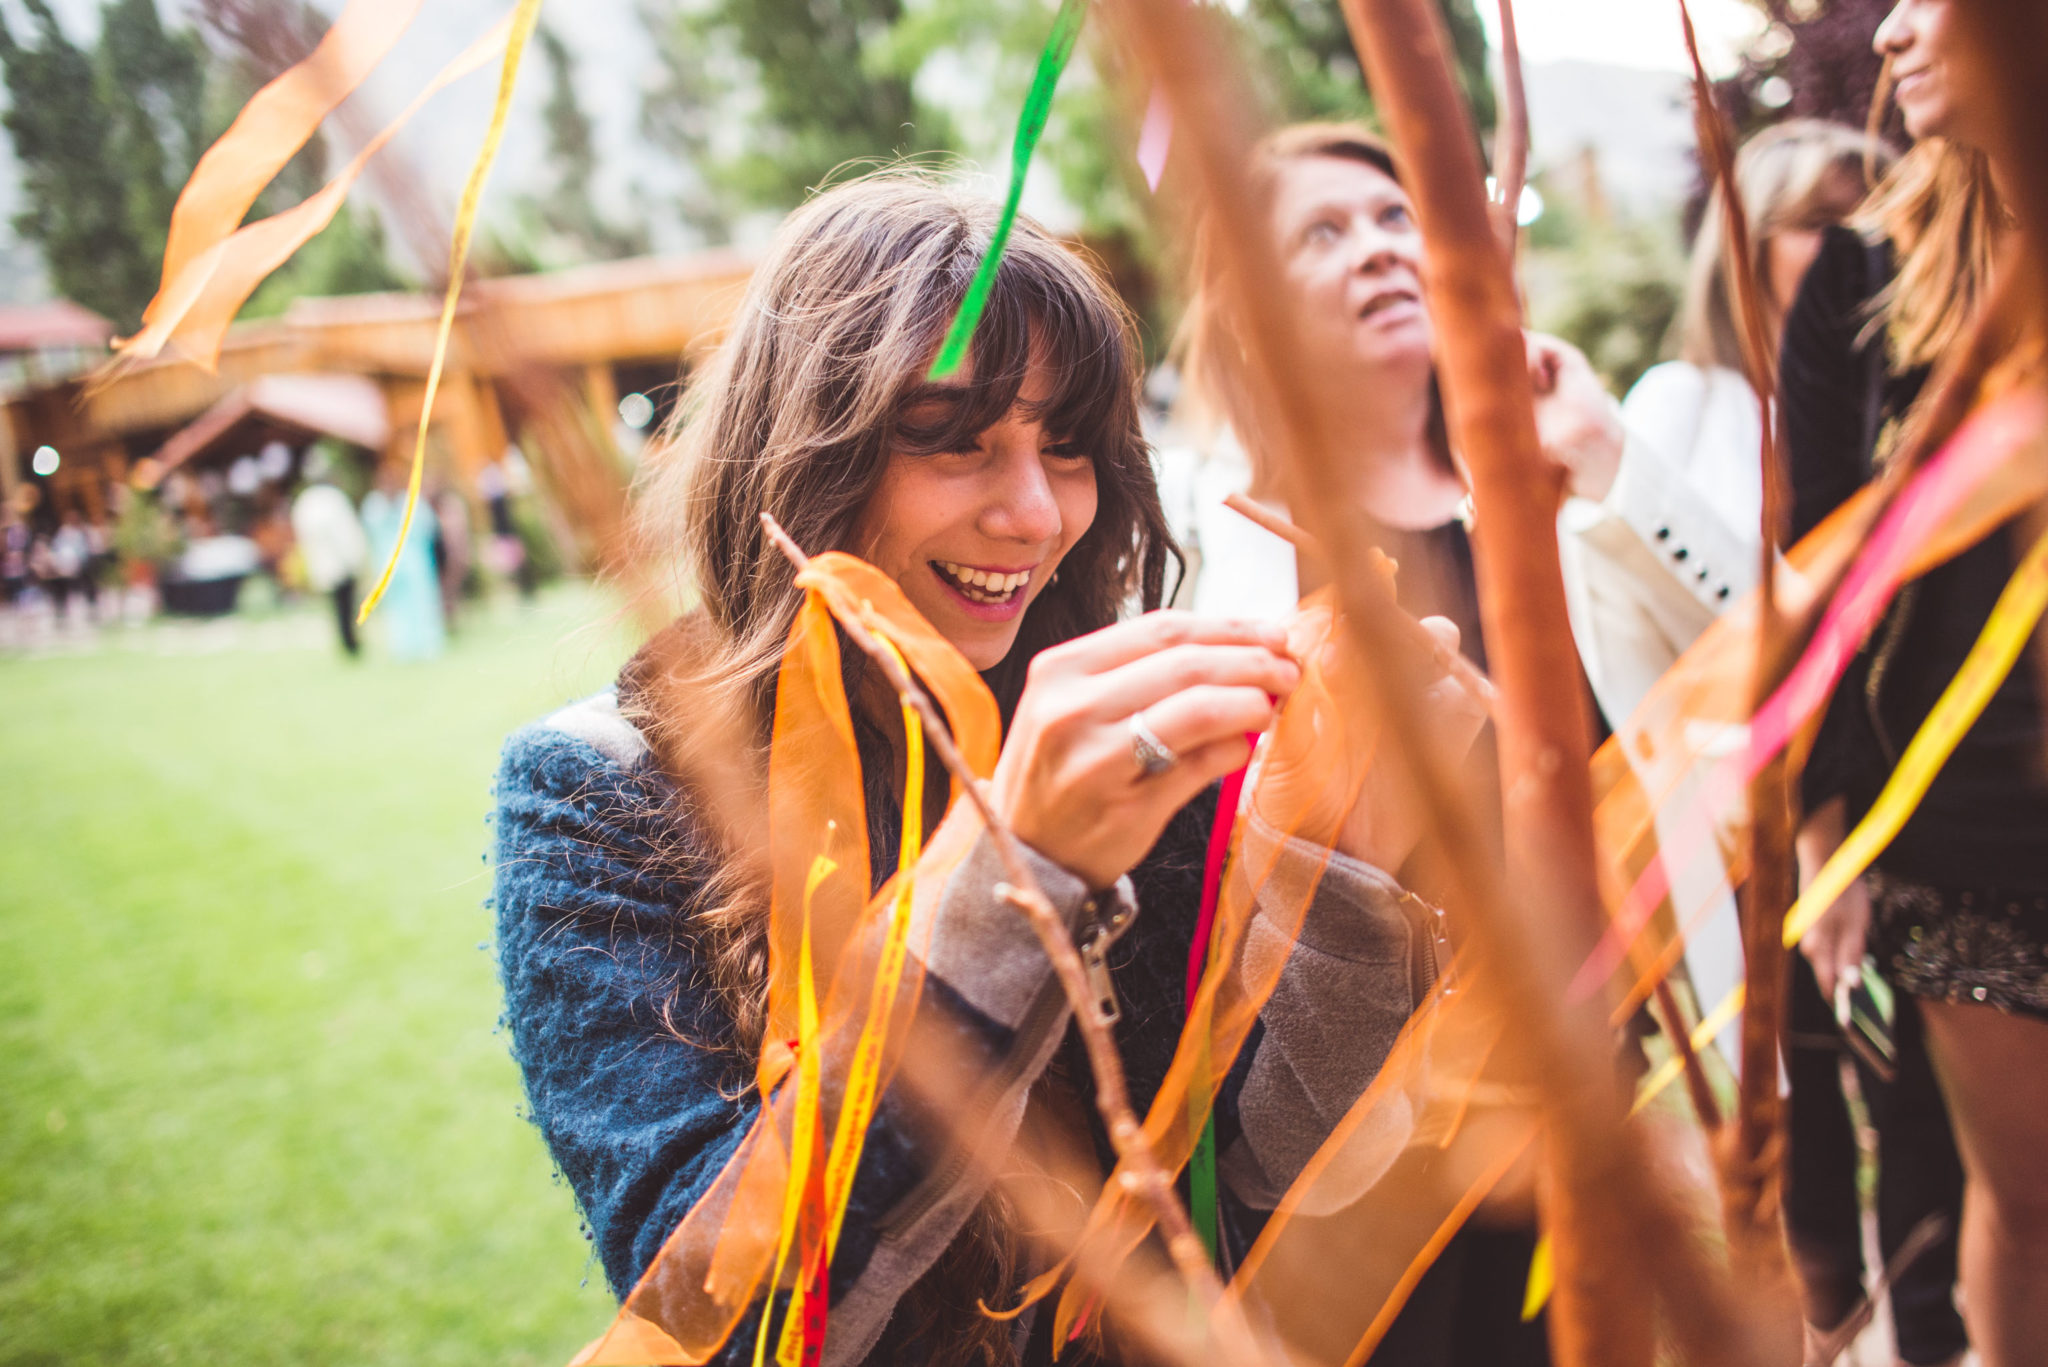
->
xmin=991 ymin=611 xmax=1300 ymax=887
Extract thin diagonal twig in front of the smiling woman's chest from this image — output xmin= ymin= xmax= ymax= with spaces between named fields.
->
xmin=762 ymin=512 xmax=1257 ymax=1361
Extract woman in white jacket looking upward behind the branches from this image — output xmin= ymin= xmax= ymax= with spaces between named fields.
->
xmin=1159 ymin=123 xmax=1662 ymax=1363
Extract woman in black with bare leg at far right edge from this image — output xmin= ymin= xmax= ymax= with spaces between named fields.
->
xmin=1782 ymin=0 xmax=2048 ymax=1367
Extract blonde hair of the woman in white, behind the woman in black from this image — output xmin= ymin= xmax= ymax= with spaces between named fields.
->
xmin=1673 ymin=119 xmax=1892 ymax=371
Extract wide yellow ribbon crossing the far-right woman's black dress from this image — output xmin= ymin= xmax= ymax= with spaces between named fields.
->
xmin=1786 ymin=531 xmax=2048 ymax=945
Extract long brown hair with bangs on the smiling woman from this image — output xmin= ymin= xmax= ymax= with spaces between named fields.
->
xmin=625 ymin=170 xmax=1178 ymax=1363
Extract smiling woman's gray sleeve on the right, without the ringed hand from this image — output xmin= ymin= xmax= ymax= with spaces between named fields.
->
xmin=1219 ymin=818 xmax=1440 ymax=1209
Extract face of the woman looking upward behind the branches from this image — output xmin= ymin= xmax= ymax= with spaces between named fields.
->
xmin=1272 ymin=156 xmax=1432 ymax=385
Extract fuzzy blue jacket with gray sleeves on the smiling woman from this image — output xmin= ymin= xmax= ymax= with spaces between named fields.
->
xmin=494 ymin=693 xmax=1417 ymax=1363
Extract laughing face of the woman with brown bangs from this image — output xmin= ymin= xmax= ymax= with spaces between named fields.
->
xmin=854 ymin=361 xmax=1096 ymax=670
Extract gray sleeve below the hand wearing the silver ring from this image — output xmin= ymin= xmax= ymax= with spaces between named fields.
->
xmin=825 ymin=834 xmax=1135 ymax=1367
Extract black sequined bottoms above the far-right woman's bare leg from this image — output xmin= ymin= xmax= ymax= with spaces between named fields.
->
xmin=1868 ymin=869 xmax=2048 ymax=1019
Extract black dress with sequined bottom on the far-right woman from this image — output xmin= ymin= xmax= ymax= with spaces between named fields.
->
xmin=1782 ymin=230 xmax=2048 ymax=1019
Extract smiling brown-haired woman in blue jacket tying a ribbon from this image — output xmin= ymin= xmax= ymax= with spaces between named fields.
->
xmin=498 ymin=174 xmax=1479 ymax=1365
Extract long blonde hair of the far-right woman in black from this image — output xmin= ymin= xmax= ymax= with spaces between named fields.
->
xmin=1853 ymin=137 xmax=2005 ymax=371
